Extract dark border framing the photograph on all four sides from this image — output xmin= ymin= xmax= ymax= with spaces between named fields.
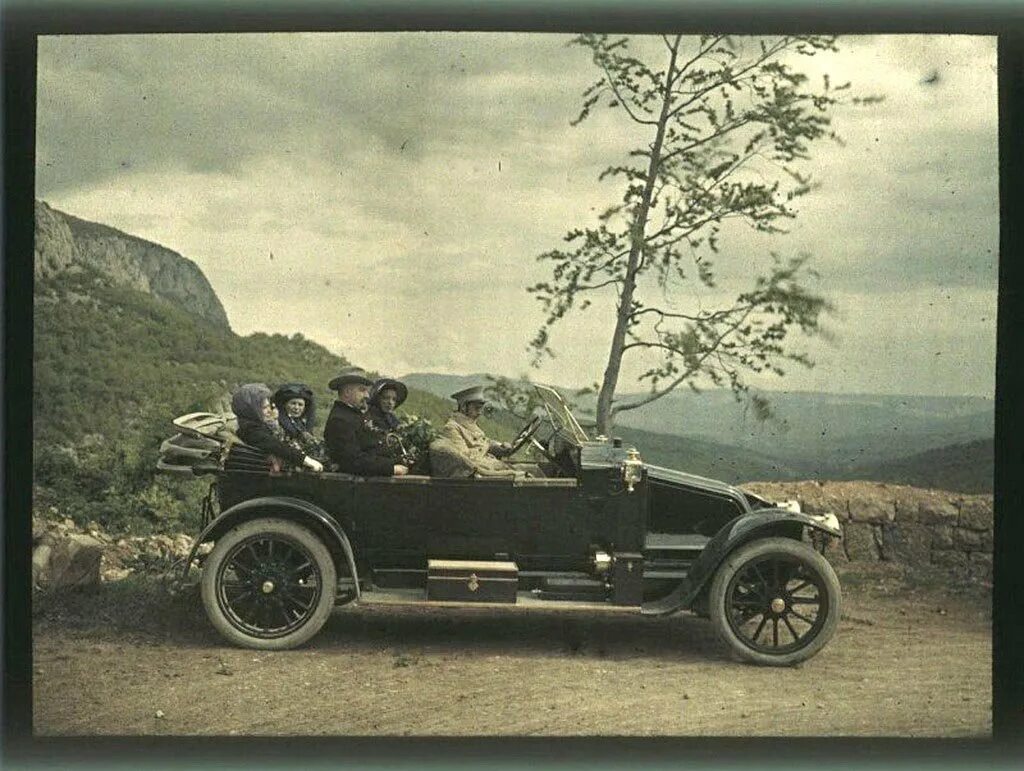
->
xmin=0 ymin=0 xmax=1024 ymax=768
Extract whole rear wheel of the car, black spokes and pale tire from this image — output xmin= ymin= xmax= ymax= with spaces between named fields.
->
xmin=201 ymin=519 xmax=337 ymax=650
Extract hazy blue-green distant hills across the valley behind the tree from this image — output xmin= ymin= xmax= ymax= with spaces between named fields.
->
xmin=404 ymin=373 xmax=994 ymax=489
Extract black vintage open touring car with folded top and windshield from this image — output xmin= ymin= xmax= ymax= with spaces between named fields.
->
xmin=159 ymin=386 xmax=842 ymax=666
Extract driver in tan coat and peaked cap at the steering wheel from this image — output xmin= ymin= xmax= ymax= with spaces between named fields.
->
xmin=430 ymin=386 xmax=543 ymax=477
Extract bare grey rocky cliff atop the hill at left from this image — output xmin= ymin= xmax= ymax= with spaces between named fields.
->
xmin=35 ymin=201 xmax=229 ymax=329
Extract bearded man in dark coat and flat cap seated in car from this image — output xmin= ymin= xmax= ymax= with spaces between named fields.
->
xmin=324 ymin=367 xmax=409 ymax=476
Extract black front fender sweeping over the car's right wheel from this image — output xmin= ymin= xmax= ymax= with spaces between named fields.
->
xmin=642 ymin=508 xmax=843 ymax=615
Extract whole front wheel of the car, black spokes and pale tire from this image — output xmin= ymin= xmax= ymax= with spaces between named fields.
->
xmin=708 ymin=538 xmax=842 ymax=667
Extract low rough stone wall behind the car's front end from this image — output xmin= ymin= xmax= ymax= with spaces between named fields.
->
xmin=742 ymin=482 xmax=992 ymax=582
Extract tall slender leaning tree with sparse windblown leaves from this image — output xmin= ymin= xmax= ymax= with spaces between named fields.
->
xmin=528 ymin=35 xmax=879 ymax=433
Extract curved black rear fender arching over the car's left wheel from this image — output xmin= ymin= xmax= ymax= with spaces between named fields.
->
xmin=181 ymin=496 xmax=359 ymax=599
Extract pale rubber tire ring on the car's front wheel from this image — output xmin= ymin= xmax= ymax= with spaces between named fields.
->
xmin=708 ymin=538 xmax=843 ymax=667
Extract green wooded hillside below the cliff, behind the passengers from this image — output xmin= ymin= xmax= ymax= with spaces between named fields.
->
xmin=33 ymin=270 xmax=514 ymax=533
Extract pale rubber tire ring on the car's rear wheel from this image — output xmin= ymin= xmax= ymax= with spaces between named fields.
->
xmin=200 ymin=519 xmax=338 ymax=650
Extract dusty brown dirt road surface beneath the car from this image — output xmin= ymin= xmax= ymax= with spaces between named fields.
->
xmin=34 ymin=561 xmax=991 ymax=736
